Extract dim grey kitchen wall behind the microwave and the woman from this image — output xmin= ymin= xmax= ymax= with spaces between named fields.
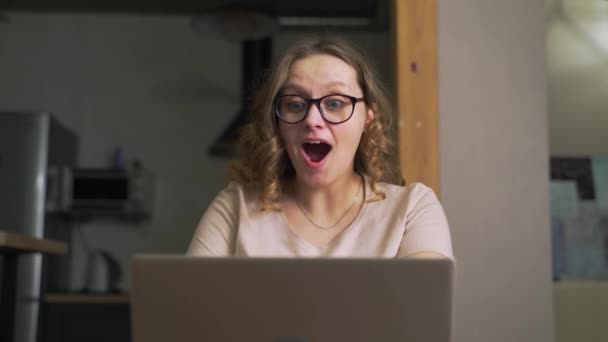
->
xmin=0 ymin=13 xmax=391 ymax=290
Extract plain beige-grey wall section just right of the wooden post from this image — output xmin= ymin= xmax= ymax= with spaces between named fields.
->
xmin=438 ymin=0 xmax=554 ymax=342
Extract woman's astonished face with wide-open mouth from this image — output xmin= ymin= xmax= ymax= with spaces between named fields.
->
xmin=279 ymin=54 xmax=374 ymax=188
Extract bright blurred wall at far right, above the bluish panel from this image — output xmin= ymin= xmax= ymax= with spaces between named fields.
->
xmin=546 ymin=0 xmax=608 ymax=157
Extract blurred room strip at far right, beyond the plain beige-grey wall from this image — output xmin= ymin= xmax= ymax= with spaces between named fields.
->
xmin=546 ymin=0 xmax=608 ymax=341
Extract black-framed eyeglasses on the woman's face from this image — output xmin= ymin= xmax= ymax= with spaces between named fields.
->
xmin=274 ymin=94 xmax=365 ymax=124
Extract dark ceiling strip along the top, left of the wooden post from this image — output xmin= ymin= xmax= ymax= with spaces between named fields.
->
xmin=0 ymin=0 xmax=389 ymax=31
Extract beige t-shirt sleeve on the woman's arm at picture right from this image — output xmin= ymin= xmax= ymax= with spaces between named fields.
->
xmin=397 ymin=183 xmax=454 ymax=259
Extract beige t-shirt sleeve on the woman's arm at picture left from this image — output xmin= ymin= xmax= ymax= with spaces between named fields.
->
xmin=186 ymin=183 xmax=239 ymax=256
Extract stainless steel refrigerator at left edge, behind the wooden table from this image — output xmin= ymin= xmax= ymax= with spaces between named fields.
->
xmin=0 ymin=112 xmax=78 ymax=342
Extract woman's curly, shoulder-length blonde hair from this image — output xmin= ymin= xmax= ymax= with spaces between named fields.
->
xmin=230 ymin=38 xmax=403 ymax=210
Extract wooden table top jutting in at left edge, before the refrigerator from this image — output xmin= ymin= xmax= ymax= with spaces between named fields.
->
xmin=0 ymin=229 xmax=68 ymax=254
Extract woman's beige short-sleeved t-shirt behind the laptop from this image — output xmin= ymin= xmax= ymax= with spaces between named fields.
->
xmin=187 ymin=182 xmax=453 ymax=259
